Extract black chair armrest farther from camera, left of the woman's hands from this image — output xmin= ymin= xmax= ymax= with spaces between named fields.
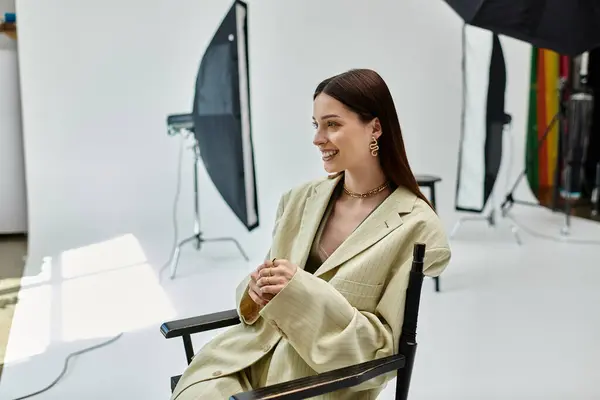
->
xmin=160 ymin=309 xmax=240 ymax=339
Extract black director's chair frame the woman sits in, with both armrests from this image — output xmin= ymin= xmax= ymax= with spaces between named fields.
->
xmin=160 ymin=243 xmax=425 ymax=400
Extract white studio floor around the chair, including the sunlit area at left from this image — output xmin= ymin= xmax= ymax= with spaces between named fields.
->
xmin=0 ymin=209 xmax=600 ymax=400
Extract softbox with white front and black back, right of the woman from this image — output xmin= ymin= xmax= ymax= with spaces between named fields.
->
xmin=455 ymin=25 xmax=510 ymax=212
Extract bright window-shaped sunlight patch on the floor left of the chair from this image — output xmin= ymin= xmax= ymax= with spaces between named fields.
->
xmin=6 ymin=234 xmax=177 ymax=364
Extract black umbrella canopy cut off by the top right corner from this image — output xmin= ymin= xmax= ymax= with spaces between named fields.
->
xmin=445 ymin=0 xmax=600 ymax=55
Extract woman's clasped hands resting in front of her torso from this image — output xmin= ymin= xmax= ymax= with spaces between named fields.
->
xmin=248 ymin=258 xmax=298 ymax=307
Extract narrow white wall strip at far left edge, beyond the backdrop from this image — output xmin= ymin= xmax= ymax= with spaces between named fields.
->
xmin=0 ymin=0 xmax=27 ymax=234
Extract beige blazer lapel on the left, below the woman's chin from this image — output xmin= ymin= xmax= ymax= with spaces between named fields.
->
xmin=291 ymin=176 xmax=341 ymax=269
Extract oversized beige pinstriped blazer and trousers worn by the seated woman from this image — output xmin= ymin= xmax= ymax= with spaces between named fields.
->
xmin=173 ymin=177 xmax=450 ymax=399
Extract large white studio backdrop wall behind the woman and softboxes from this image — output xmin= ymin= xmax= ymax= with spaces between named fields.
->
xmin=17 ymin=0 xmax=529 ymax=266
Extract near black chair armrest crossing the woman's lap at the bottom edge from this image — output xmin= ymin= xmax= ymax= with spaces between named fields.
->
xmin=230 ymin=354 xmax=406 ymax=400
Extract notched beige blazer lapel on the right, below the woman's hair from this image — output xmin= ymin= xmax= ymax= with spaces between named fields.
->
xmin=315 ymin=188 xmax=416 ymax=276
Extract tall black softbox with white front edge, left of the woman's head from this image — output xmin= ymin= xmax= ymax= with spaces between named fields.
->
xmin=192 ymin=1 xmax=259 ymax=231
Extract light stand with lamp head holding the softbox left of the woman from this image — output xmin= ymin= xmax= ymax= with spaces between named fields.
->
xmin=167 ymin=114 xmax=250 ymax=279
